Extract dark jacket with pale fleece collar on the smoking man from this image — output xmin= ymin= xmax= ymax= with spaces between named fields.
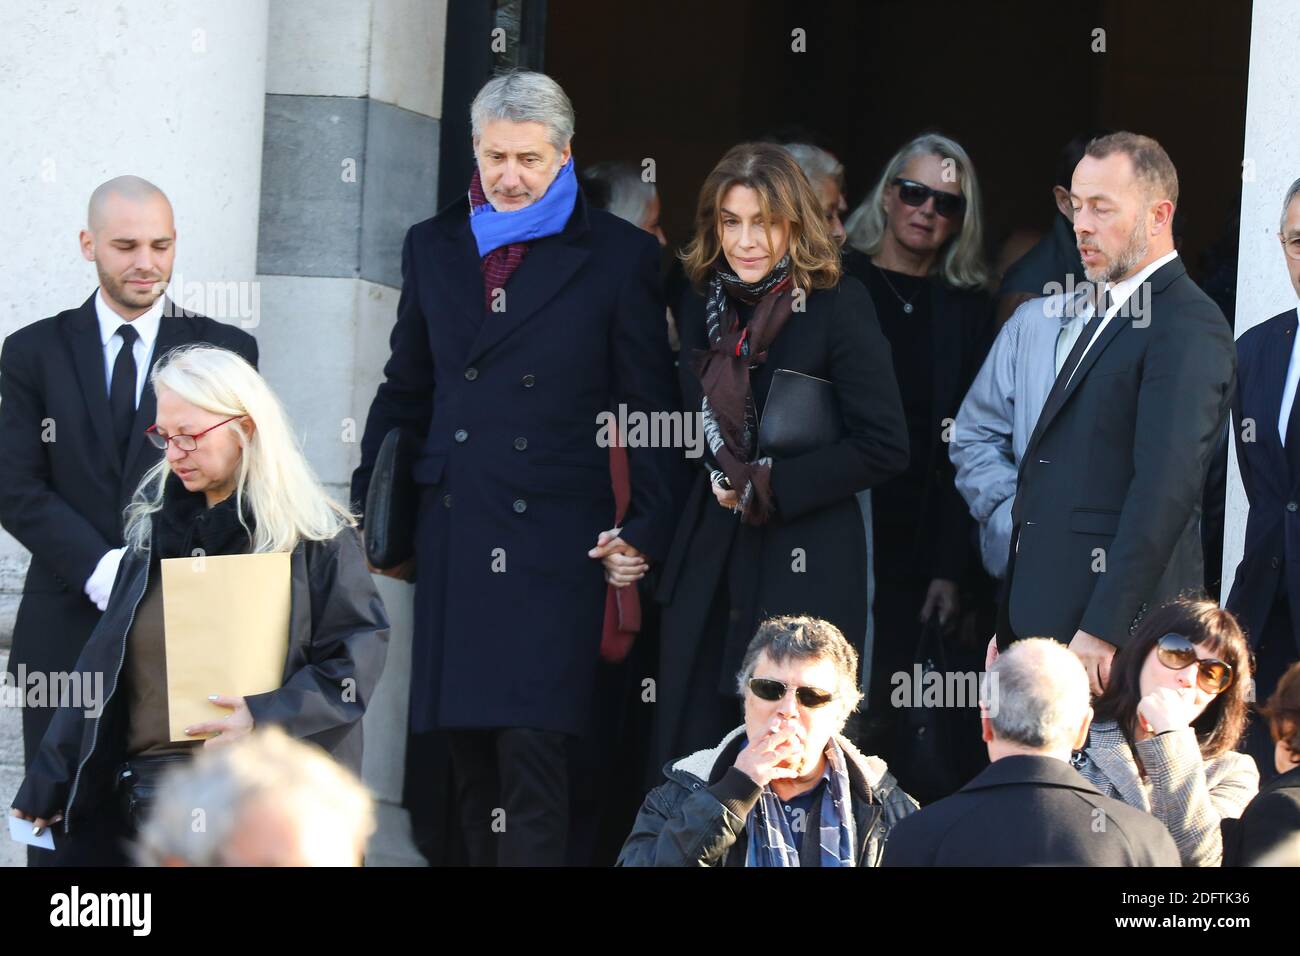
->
xmin=618 ymin=726 xmax=917 ymax=866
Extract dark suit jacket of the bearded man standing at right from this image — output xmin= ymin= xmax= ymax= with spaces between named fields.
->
xmin=998 ymin=259 xmax=1236 ymax=646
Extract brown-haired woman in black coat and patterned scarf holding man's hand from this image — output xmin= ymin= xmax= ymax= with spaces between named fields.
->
xmin=655 ymin=143 xmax=907 ymax=760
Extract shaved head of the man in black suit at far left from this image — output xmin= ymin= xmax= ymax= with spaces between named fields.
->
xmin=81 ymin=176 xmax=176 ymax=320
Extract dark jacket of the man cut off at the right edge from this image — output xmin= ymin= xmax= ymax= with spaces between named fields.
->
xmin=1227 ymin=308 xmax=1300 ymax=650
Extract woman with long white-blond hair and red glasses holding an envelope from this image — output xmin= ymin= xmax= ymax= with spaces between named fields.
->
xmin=13 ymin=346 xmax=389 ymax=865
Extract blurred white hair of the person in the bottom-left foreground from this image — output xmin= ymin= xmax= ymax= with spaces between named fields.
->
xmin=135 ymin=727 xmax=374 ymax=866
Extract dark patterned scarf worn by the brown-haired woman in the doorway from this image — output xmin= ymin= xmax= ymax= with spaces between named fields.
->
xmin=693 ymin=254 xmax=793 ymax=524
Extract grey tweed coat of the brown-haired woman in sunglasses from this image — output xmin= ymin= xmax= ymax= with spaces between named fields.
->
xmin=1073 ymin=721 xmax=1260 ymax=866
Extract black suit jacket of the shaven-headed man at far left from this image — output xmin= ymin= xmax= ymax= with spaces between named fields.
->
xmin=0 ymin=295 xmax=257 ymax=760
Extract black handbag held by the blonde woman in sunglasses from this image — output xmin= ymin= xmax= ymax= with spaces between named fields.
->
xmin=893 ymin=613 xmax=965 ymax=804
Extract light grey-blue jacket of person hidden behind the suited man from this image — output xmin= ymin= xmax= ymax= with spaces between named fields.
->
xmin=948 ymin=290 xmax=1088 ymax=578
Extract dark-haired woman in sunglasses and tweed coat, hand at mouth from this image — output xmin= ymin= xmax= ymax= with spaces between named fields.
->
xmin=1074 ymin=600 xmax=1260 ymax=866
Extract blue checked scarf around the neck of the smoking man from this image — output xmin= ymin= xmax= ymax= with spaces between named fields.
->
xmin=745 ymin=737 xmax=857 ymax=866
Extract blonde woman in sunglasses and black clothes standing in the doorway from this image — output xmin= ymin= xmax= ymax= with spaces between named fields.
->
xmin=844 ymin=134 xmax=993 ymax=800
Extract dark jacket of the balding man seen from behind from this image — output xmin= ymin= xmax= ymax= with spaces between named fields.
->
xmin=884 ymin=754 xmax=1179 ymax=866
